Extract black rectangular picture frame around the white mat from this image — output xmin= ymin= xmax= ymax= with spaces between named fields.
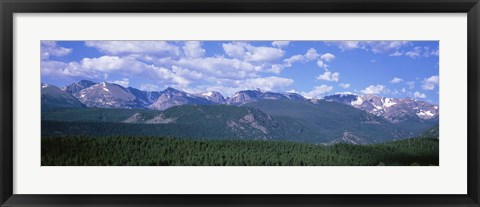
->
xmin=0 ymin=0 xmax=480 ymax=207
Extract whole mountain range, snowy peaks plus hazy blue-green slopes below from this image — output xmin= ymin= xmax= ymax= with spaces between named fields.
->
xmin=42 ymin=80 xmax=439 ymax=144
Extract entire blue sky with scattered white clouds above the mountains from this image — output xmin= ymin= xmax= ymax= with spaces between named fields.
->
xmin=41 ymin=41 xmax=439 ymax=103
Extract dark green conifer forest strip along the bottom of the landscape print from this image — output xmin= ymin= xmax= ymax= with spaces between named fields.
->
xmin=42 ymin=136 xmax=439 ymax=166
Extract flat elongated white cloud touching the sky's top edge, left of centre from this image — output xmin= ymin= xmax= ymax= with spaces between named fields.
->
xmin=85 ymin=41 xmax=180 ymax=56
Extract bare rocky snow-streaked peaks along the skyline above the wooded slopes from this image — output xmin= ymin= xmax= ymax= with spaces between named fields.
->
xmin=47 ymin=80 xmax=438 ymax=119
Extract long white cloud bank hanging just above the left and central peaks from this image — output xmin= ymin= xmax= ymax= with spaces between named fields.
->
xmin=49 ymin=41 xmax=284 ymax=87
